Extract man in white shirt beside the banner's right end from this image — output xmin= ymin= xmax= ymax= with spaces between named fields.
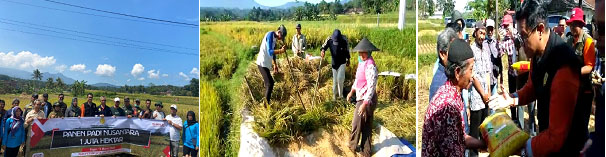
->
xmin=164 ymin=104 xmax=183 ymax=157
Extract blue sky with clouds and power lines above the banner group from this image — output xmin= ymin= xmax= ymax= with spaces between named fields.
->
xmin=0 ymin=0 xmax=199 ymax=86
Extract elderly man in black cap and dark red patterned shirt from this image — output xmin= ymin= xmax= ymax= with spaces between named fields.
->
xmin=421 ymin=39 xmax=485 ymax=157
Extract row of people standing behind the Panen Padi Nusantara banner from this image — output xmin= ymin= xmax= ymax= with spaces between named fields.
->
xmin=0 ymin=93 xmax=200 ymax=157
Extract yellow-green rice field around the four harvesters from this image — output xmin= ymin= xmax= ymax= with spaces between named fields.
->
xmin=200 ymin=13 xmax=416 ymax=156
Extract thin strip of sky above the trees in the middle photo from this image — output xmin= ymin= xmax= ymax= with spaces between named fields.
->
xmin=200 ymin=0 xmax=334 ymax=7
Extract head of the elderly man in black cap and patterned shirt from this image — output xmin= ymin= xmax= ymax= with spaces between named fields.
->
xmin=444 ymin=39 xmax=474 ymax=91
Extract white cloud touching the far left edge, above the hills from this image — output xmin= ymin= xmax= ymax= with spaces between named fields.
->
xmin=0 ymin=51 xmax=56 ymax=70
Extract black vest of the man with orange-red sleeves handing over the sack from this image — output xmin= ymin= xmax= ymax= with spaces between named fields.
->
xmin=531 ymin=32 xmax=591 ymax=156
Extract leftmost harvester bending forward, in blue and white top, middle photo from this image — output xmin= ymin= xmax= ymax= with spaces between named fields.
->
xmin=255 ymin=25 xmax=286 ymax=104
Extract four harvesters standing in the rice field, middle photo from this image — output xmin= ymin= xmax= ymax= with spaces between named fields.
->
xmin=255 ymin=24 xmax=379 ymax=156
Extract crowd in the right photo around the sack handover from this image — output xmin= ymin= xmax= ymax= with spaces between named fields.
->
xmin=422 ymin=0 xmax=604 ymax=156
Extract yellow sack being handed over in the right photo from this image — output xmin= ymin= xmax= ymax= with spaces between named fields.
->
xmin=480 ymin=112 xmax=530 ymax=157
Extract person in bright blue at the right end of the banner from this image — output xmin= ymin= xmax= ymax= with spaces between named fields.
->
xmin=183 ymin=111 xmax=200 ymax=157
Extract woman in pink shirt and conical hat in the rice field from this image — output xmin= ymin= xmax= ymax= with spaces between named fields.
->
xmin=347 ymin=38 xmax=379 ymax=156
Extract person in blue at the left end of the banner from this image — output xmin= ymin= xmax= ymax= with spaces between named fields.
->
xmin=2 ymin=106 xmax=25 ymax=157
